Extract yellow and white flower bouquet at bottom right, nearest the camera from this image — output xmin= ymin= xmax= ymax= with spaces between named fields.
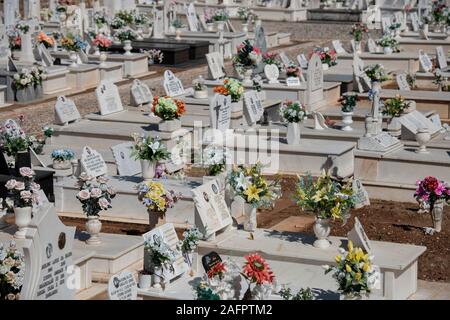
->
xmin=324 ymin=240 xmax=378 ymax=300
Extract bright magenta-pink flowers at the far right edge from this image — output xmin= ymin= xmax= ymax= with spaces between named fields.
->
xmin=414 ymin=177 xmax=450 ymax=207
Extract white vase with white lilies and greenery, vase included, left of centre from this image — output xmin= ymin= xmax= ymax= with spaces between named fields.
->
xmin=131 ymin=133 xmax=169 ymax=180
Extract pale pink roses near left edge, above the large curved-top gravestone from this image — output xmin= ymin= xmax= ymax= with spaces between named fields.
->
xmin=5 ymin=167 xmax=41 ymax=208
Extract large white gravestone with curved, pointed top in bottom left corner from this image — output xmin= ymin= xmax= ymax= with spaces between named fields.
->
xmin=20 ymin=203 xmax=79 ymax=300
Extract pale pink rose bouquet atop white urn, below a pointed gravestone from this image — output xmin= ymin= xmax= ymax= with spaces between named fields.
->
xmin=76 ymin=172 xmax=116 ymax=217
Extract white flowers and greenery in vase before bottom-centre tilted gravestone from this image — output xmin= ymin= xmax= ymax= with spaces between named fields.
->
xmin=144 ymin=235 xmax=176 ymax=288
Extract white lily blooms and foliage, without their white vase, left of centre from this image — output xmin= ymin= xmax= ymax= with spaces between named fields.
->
xmin=131 ymin=133 xmax=169 ymax=162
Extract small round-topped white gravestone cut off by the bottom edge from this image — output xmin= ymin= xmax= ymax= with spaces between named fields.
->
xmin=108 ymin=271 xmax=137 ymax=300
